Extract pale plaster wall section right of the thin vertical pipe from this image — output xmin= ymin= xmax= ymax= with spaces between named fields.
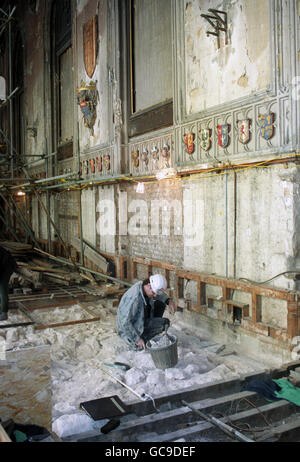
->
xmin=237 ymin=166 xmax=297 ymax=289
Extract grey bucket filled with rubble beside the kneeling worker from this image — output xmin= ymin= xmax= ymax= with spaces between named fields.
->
xmin=146 ymin=334 xmax=178 ymax=369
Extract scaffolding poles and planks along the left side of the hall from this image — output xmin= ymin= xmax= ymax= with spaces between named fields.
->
xmin=0 ymin=4 xmax=131 ymax=286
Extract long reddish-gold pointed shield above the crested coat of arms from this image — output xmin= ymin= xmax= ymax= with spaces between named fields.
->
xmin=83 ymin=16 xmax=97 ymax=79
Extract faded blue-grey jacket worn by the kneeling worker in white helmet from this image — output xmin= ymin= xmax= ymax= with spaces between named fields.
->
xmin=116 ymin=281 xmax=170 ymax=345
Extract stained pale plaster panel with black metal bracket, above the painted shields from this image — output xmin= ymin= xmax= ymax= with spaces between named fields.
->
xmin=185 ymin=0 xmax=270 ymax=114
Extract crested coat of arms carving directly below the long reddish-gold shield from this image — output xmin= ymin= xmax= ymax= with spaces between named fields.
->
xmin=77 ymin=80 xmax=98 ymax=136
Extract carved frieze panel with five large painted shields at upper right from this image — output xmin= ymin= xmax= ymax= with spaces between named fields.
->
xmin=175 ymin=97 xmax=284 ymax=167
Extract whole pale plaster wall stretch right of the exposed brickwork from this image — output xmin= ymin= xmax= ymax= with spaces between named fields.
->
xmin=183 ymin=166 xmax=298 ymax=289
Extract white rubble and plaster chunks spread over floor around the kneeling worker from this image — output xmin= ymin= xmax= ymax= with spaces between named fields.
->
xmin=0 ymin=301 xmax=263 ymax=437
